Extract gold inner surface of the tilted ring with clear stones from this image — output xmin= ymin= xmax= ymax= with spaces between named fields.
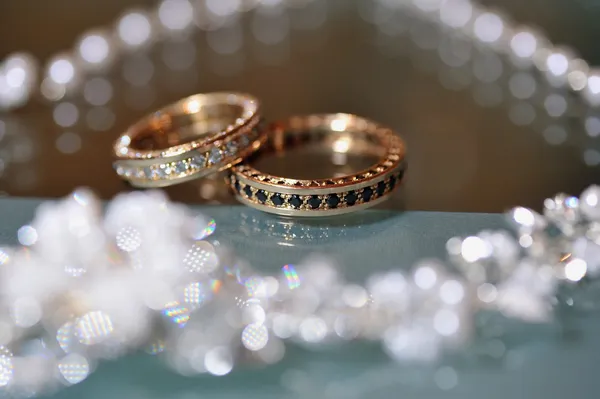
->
xmin=130 ymin=104 xmax=244 ymax=150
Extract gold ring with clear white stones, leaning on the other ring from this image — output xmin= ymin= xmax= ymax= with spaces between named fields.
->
xmin=113 ymin=93 xmax=264 ymax=188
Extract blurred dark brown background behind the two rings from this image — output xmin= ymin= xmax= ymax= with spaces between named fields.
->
xmin=0 ymin=0 xmax=600 ymax=212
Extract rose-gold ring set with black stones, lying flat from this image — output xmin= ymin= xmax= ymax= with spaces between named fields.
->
xmin=230 ymin=114 xmax=406 ymax=217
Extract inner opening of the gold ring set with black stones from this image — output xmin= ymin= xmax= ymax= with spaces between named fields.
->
xmin=249 ymin=129 xmax=386 ymax=180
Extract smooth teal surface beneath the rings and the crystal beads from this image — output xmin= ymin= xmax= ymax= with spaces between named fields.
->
xmin=0 ymin=199 xmax=600 ymax=399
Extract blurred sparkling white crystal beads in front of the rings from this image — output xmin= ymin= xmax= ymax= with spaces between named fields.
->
xmin=0 ymin=186 xmax=600 ymax=396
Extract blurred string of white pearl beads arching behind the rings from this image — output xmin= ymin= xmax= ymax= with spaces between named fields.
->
xmin=0 ymin=0 xmax=600 ymax=110
